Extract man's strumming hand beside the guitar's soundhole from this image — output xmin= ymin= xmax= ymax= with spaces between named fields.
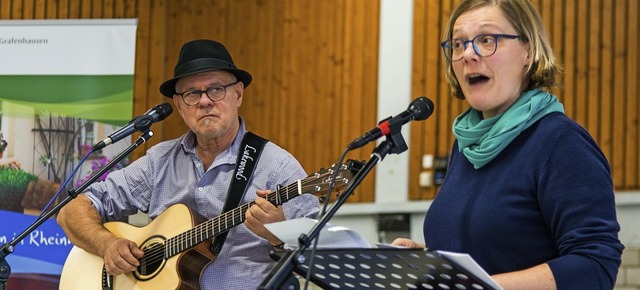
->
xmin=103 ymin=238 xmax=144 ymax=276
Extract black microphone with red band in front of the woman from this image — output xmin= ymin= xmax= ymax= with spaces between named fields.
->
xmin=347 ymin=97 xmax=433 ymax=150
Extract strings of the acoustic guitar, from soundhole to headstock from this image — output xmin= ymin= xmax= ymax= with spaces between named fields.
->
xmin=138 ymin=173 xmax=340 ymax=268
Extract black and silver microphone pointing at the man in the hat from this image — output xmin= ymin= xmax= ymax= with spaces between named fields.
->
xmin=91 ymin=103 xmax=173 ymax=151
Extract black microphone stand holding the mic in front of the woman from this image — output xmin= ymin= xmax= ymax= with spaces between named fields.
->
xmin=257 ymin=122 xmax=408 ymax=290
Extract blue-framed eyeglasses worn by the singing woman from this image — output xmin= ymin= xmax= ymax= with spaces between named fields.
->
xmin=440 ymin=34 xmax=521 ymax=62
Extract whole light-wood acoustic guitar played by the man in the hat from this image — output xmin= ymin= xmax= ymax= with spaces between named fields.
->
xmin=60 ymin=160 xmax=363 ymax=290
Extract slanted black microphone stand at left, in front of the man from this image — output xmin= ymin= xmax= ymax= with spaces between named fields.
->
xmin=0 ymin=130 xmax=153 ymax=290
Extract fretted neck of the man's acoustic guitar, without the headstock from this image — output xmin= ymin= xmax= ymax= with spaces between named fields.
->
xmin=164 ymin=180 xmax=303 ymax=258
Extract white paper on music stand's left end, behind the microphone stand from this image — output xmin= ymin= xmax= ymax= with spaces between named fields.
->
xmin=265 ymin=218 xmax=371 ymax=249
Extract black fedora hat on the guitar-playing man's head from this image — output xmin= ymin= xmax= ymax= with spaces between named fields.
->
xmin=160 ymin=39 xmax=252 ymax=98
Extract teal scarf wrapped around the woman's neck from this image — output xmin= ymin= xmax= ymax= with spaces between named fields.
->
xmin=453 ymin=89 xmax=564 ymax=169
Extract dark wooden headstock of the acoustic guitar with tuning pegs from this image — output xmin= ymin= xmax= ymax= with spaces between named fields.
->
xmin=301 ymin=159 xmax=364 ymax=197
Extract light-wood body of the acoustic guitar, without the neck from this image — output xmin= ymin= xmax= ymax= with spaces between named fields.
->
xmin=60 ymin=204 xmax=215 ymax=290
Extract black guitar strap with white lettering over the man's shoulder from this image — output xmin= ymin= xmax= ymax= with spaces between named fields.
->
xmin=211 ymin=132 xmax=269 ymax=255
